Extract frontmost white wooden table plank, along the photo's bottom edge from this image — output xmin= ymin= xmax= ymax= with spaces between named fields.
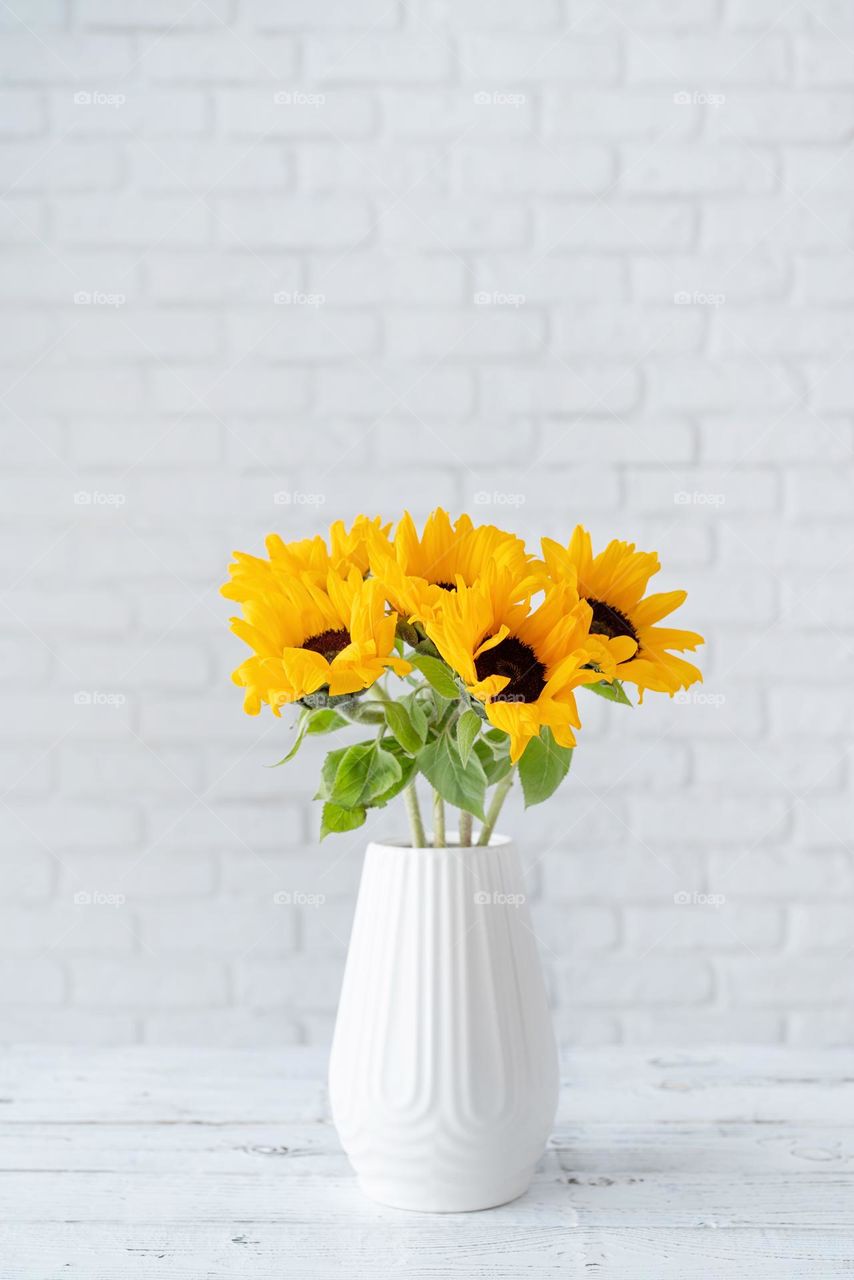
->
xmin=0 ymin=1210 xmax=854 ymax=1280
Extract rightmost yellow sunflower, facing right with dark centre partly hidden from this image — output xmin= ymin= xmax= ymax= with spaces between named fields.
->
xmin=542 ymin=525 xmax=704 ymax=701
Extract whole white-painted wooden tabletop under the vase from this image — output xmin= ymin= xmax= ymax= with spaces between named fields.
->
xmin=0 ymin=1047 xmax=854 ymax=1280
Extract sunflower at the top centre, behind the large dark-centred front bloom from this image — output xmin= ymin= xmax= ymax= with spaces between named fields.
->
xmin=369 ymin=507 xmax=535 ymax=622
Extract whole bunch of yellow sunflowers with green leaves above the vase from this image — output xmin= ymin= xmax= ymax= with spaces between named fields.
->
xmin=222 ymin=509 xmax=703 ymax=847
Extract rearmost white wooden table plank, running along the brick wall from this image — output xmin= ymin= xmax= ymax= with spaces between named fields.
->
xmin=0 ymin=1046 xmax=854 ymax=1125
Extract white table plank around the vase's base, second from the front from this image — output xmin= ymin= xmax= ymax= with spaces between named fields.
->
xmin=0 ymin=1157 xmax=854 ymax=1230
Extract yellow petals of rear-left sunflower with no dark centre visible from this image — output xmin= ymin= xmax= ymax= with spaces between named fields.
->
xmin=222 ymin=516 xmax=392 ymax=600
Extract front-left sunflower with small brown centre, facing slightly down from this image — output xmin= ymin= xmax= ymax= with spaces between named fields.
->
xmin=223 ymin=564 xmax=412 ymax=716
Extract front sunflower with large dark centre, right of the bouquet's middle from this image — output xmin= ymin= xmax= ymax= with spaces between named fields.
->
xmin=425 ymin=567 xmax=635 ymax=763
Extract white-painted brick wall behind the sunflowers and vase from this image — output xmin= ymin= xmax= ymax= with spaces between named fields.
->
xmin=0 ymin=0 xmax=854 ymax=1043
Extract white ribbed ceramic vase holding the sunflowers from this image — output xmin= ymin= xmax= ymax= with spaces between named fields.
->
xmin=329 ymin=837 xmax=558 ymax=1212
